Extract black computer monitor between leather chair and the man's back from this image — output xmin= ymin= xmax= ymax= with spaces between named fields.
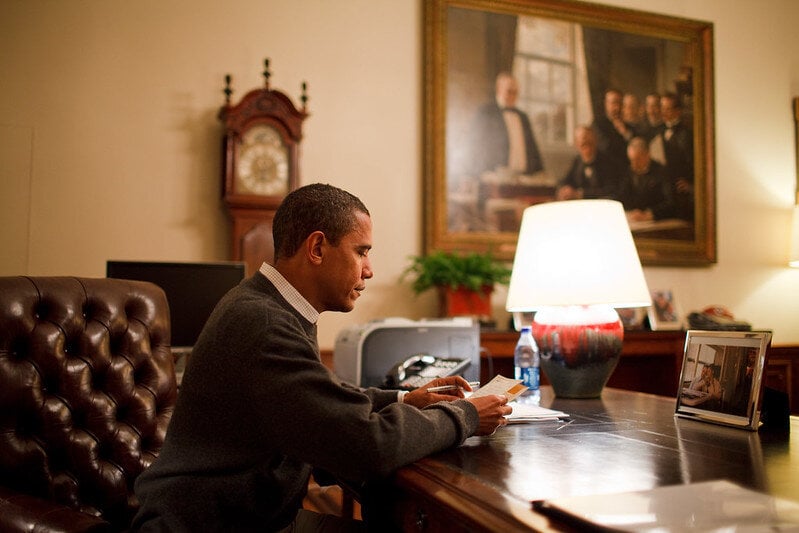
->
xmin=106 ymin=261 xmax=244 ymax=348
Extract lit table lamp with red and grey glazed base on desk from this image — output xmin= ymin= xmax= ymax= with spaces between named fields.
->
xmin=505 ymin=200 xmax=651 ymax=398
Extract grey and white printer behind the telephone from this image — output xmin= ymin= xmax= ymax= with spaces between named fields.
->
xmin=333 ymin=317 xmax=480 ymax=388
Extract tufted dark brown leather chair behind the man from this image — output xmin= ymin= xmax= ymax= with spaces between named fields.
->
xmin=0 ymin=277 xmax=177 ymax=532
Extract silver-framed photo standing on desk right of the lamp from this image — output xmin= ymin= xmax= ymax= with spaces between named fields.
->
xmin=676 ymin=330 xmax=771 ymax=431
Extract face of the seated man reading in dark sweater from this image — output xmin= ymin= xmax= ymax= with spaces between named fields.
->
xmin=320 ymin=212 xmax=373 ymax=312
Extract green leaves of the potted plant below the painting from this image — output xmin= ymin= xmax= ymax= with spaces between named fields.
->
xmin=402 ymin=251 xmax=511 ymax=294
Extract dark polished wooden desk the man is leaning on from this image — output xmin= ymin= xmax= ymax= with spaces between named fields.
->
xmin=377 ymin=387 xmax=799 ymax=532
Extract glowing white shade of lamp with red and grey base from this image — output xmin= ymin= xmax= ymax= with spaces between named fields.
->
xmin=505 ymin=200 xmax=651 ymax=312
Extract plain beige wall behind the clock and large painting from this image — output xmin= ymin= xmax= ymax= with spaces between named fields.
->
xmin=0 ymin=0 xmax=799 ymax=348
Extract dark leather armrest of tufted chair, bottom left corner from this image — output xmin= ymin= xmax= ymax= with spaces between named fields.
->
xmin=0 ymin=487 xmax=113 ymax=533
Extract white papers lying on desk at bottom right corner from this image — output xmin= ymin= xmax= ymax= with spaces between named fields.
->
xmin=533 ymin=480 xmax=799 ymax=533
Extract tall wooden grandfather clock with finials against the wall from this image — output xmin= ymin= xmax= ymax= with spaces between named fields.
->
xmin=219 ymin=59 xmax=308 ymax=275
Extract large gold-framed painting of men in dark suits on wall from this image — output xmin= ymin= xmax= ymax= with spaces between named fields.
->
xmin=424 ymin=0 xmax=716 ymax=265
